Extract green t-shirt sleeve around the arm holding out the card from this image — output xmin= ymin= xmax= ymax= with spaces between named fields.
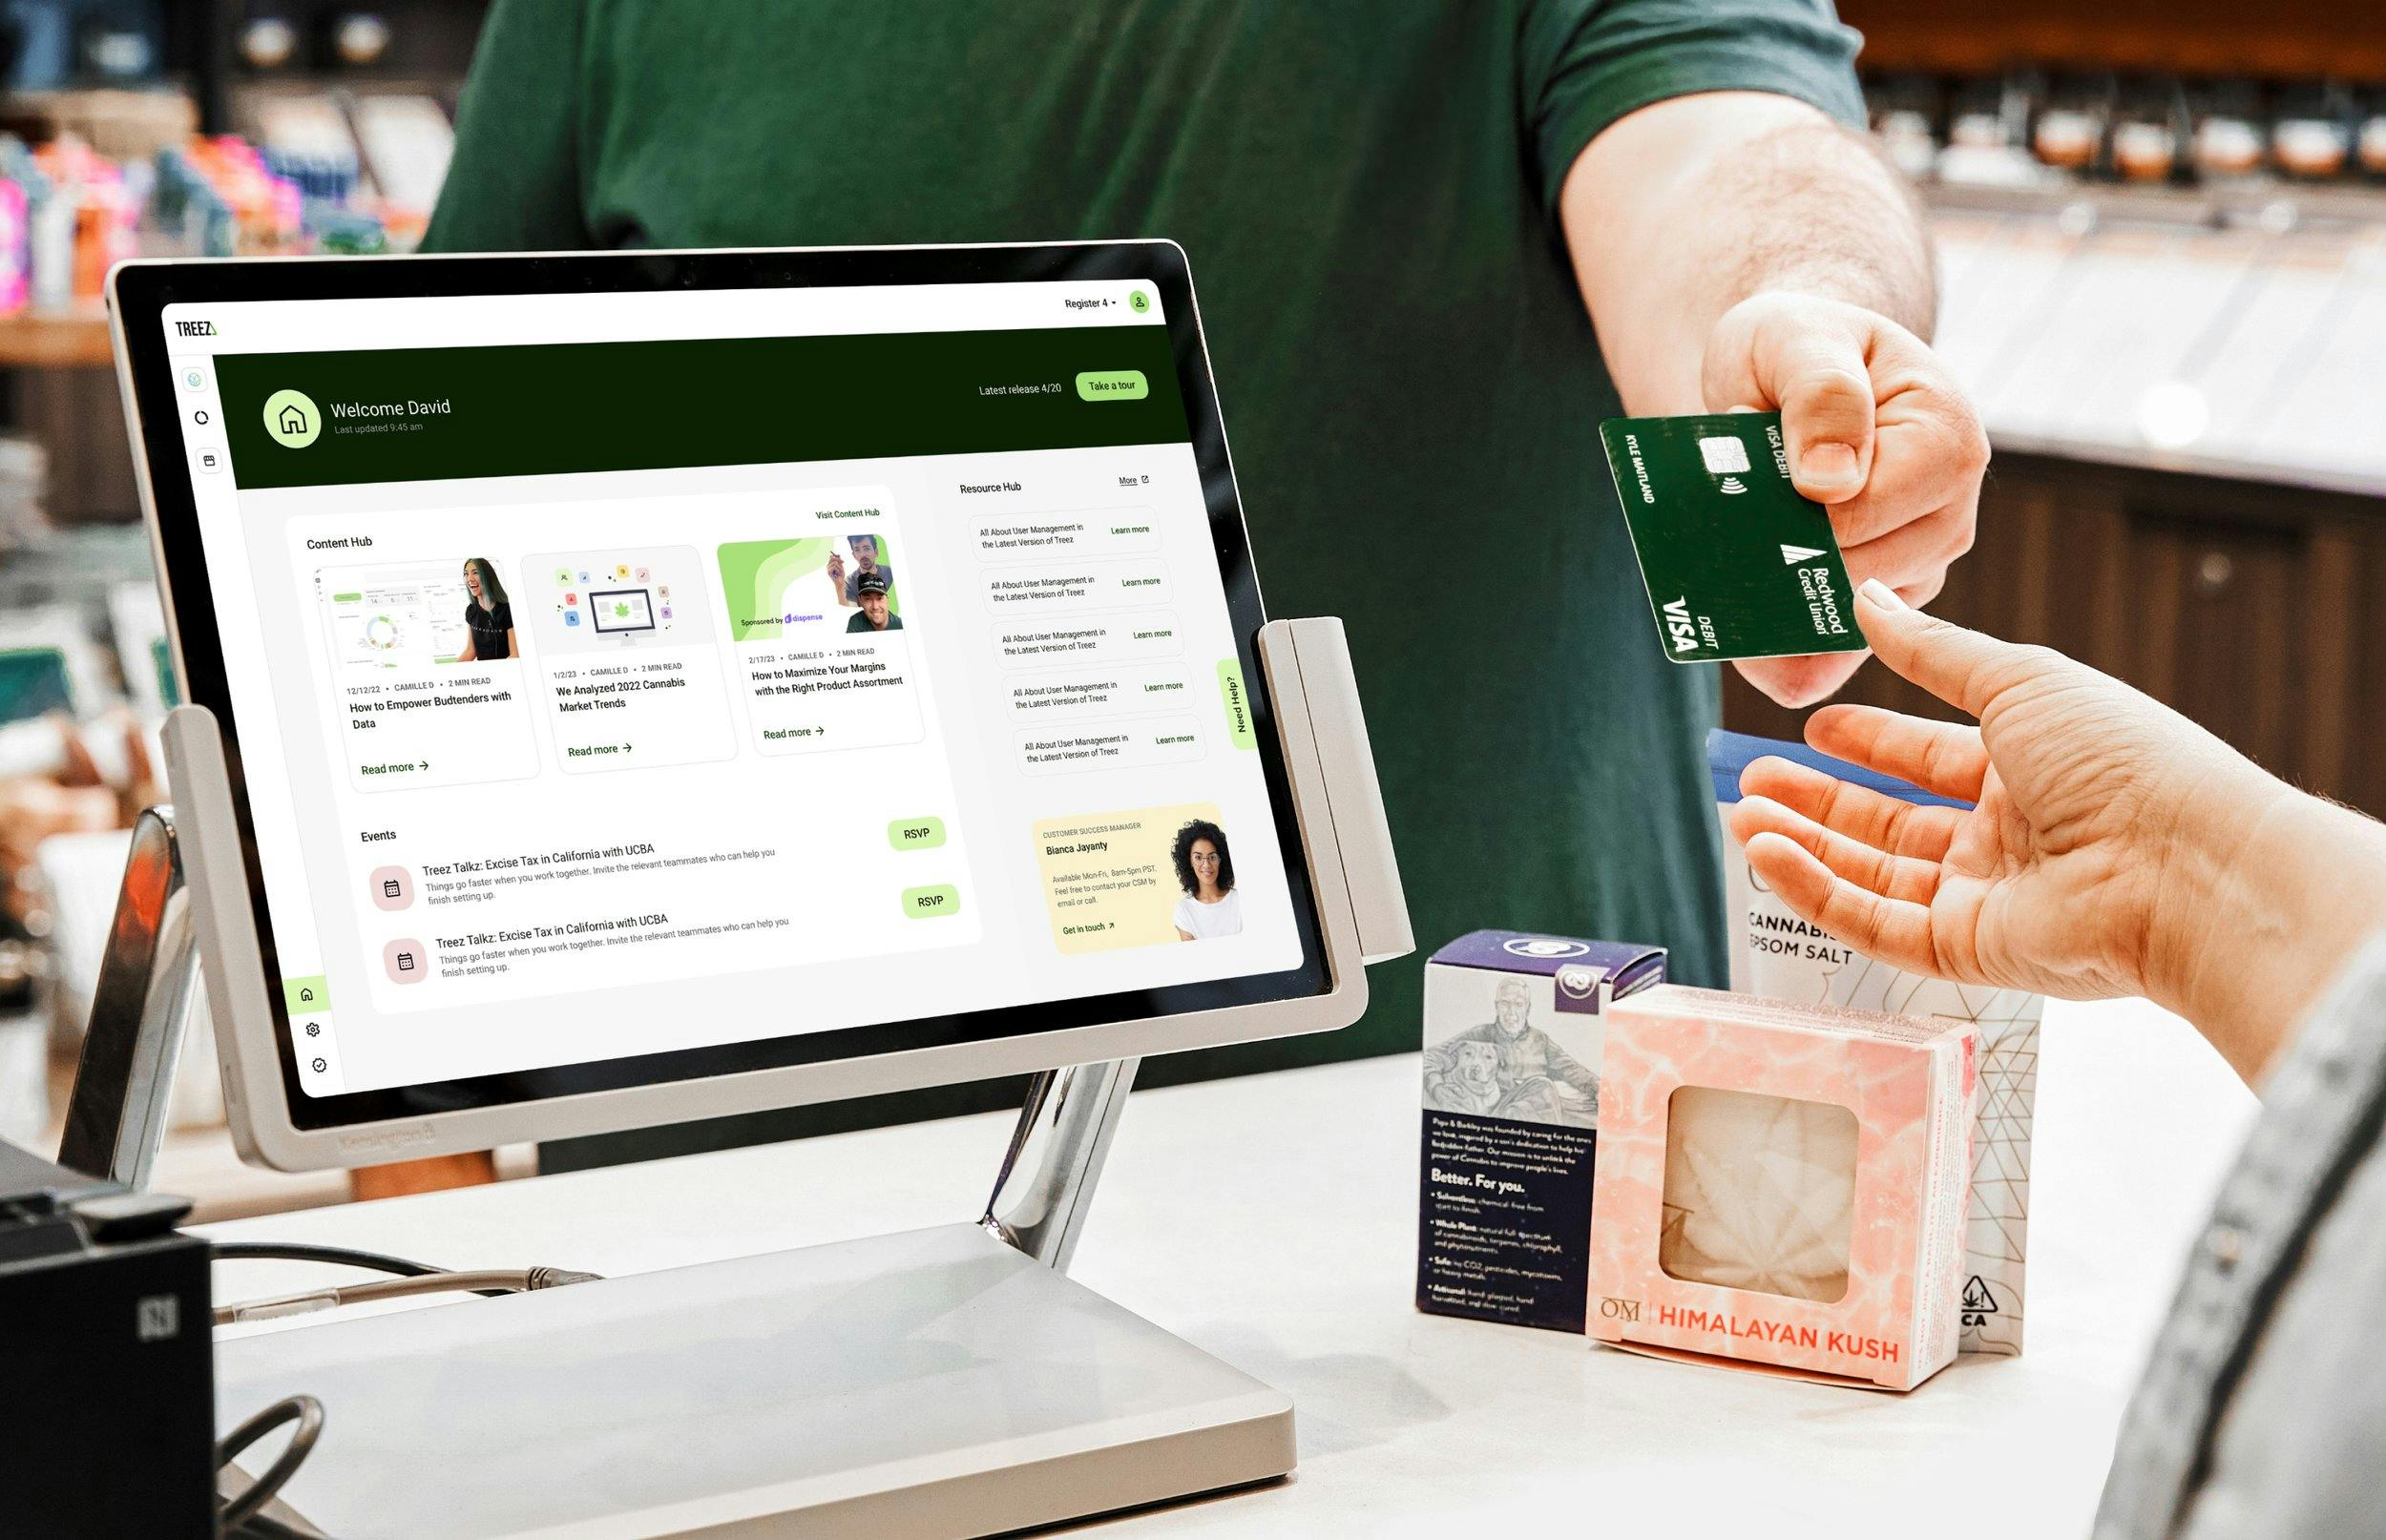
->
xmin=1517 ymin=0 xmax=1864 ymax=210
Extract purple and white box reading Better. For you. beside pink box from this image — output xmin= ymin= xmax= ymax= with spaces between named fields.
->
xmin=1417 ymin=929 xmax=1665 ymax=1333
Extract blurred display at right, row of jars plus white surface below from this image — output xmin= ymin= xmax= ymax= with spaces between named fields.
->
xmin=1869 ymin=69 xmax=2386 ymax=491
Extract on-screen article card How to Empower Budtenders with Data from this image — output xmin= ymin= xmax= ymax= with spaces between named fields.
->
xmin=315 ymin=553 xmax=539 ymax=791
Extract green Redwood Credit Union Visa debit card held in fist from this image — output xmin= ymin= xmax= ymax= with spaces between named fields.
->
xmin=1599 ymin=412 xmax=1864 ymax=663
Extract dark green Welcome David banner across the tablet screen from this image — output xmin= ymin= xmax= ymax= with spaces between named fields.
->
xmin=215 ymin=326 xmax=1191 ymax=489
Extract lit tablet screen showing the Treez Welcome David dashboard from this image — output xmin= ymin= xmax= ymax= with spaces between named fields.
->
xmin=135 ymin=256 xmax=1322 ymax=1120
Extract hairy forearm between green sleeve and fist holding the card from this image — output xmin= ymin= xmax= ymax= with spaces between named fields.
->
xmin=1560 ymin=93 xmax=1936 ymax=415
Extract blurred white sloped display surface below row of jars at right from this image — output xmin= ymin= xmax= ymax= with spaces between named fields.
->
xmin=1933 ymin=198 xmax=2386 ymax=495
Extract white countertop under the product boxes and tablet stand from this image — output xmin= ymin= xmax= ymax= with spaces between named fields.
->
xmin=210 ymin=1001 xmax=2255 ymax=1540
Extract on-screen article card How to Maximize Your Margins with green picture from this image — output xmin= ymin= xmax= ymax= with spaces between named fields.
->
xmin=721 ymin=527 xmax=926 ymax=754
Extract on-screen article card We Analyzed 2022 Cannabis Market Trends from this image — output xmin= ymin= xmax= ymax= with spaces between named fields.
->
xmin=523 ymin=546 xmax=738 ymax=772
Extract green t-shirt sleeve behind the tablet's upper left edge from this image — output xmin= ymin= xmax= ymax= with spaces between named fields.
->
xmin=423 ymin=0 xmax=592 ymax=250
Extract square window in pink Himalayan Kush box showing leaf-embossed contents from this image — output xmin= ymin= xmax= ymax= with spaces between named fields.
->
xmin=1656 ymin=1085 xmax=1856 ymax=1304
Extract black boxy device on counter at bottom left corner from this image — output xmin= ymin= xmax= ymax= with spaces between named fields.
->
xmin=0 ymin=1139 xmax=215 ymax=1540
